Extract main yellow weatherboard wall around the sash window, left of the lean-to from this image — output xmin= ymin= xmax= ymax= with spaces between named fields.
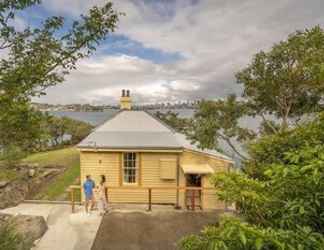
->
xmin=80 ymin=151 xmax=178 ymax=204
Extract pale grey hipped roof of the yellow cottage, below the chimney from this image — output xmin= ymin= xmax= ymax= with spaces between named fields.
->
xmin=78 ymin=110 xmax=231 ymax=160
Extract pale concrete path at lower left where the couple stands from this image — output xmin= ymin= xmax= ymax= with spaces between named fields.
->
xmin=1 ymin=204 xmax=102 ymax=250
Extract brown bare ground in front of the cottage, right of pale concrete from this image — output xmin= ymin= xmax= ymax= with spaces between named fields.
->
xmin=92 ymin=211 xmax=218 ymax=250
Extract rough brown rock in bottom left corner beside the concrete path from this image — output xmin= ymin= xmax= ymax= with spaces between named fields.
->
xmin=0 ymin=214 xmax=47 ymax=250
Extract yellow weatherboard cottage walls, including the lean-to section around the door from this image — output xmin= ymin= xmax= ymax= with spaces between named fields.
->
xmin=80 ymin=148 xmax=230 ymax=209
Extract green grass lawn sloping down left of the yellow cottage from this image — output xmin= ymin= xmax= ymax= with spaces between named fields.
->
xmin=23 ymin=147 xmax=80 ymax=200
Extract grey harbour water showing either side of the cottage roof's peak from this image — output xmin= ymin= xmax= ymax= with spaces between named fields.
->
xmin=50 ymin=109 xmax=194 ymax=126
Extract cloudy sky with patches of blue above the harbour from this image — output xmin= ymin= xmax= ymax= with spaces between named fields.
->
xmin=16 ymin=0 xmax=324 ymax=105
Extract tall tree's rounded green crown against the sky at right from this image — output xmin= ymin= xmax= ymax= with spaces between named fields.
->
xmin=236 ymin=26 xmax=324 ymax=133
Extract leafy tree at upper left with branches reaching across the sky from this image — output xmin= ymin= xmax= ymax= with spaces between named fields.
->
xmin=0 ymin=0 xmax=119 ymax=154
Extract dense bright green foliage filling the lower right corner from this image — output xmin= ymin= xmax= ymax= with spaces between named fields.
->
xmin=180 ymin=114 xmax=324 ymax=250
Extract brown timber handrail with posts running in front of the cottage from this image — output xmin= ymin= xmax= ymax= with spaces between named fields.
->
xmin=69 ymin=185 xmax=215 ymax=213
